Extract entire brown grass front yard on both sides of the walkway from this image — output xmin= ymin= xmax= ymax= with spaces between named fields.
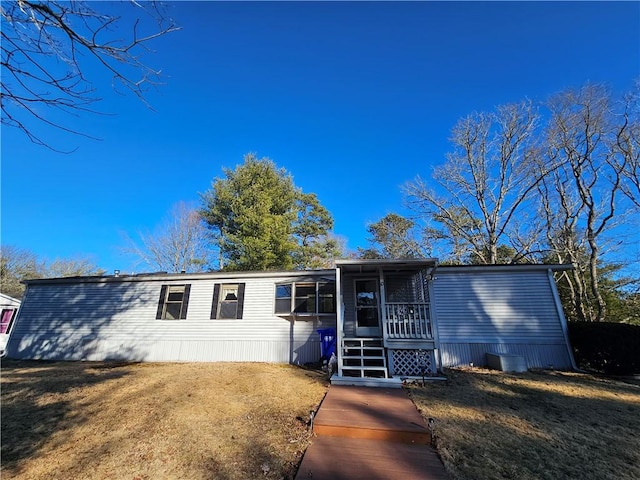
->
xmin=1 ymin=360 xmax=640 ymax=480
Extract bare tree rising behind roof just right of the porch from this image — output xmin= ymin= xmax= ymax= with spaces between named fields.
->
xmin=404 ymin=101 xmax=540 ymax=264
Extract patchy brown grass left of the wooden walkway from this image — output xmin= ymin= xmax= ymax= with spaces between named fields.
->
xmin=1 ymin=360 xmax=327 ymax=480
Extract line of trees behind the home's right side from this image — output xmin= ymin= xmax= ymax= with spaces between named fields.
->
xmin=359 ymin=84 xmax=640 ymax=321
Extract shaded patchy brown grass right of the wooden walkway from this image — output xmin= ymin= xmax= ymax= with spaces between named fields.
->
xmin=410 ymin=369 xmax=640 ymax=480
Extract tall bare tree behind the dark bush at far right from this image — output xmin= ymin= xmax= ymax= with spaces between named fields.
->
xmin=540 ymin=85 xmax=637 ymax=321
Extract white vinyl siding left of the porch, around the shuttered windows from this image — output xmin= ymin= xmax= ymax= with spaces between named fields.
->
xmin=8 ymin=277 xmax=335 ymax=363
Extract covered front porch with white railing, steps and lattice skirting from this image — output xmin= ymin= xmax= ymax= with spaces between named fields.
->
xmin=332 ymin=259 xmax=439 ymax=385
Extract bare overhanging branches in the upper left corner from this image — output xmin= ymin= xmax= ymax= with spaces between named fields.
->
xmin=0 ymin=0 xmax=178 ymax=147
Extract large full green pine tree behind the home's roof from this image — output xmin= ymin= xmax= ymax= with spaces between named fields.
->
xmin=201 ymin=154 xmax=339 ymax=270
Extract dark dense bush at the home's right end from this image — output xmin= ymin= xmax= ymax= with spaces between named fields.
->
xmin=568 ymin=322 xmax=640 ymax=375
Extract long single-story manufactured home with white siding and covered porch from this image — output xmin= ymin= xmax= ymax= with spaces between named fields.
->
xmin=7 ymin=259 xmax=575 ymax=384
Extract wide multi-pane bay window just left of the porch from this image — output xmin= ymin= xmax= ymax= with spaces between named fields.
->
xmin=275 ymin=282 xmax=336 ymax=315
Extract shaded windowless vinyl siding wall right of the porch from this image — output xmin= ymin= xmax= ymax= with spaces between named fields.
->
xmin=433 ymin=267 xmax=571 ymax=368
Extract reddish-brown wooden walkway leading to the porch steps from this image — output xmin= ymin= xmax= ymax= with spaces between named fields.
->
xmin=296 ymin=385 xmax=450 ymax=480
